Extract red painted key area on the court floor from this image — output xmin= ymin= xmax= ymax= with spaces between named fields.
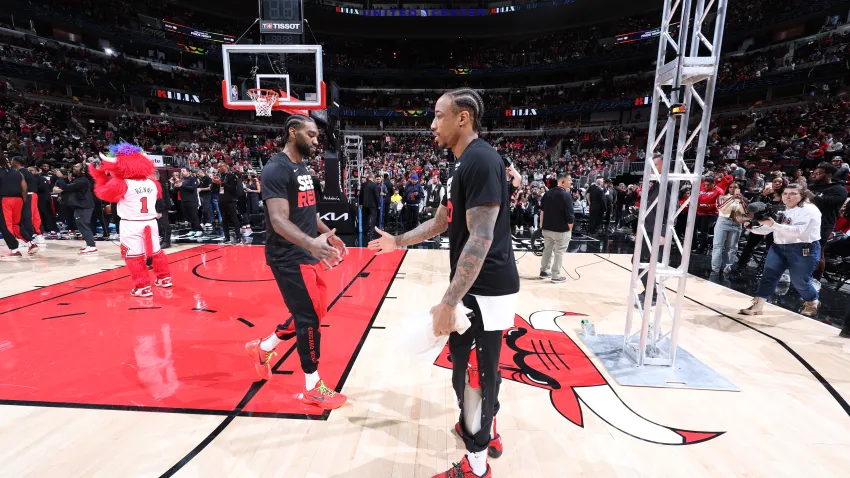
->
xmin=0 ymin=245 xmax=404 ymax=418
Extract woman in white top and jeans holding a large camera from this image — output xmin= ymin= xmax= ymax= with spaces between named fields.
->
xmin=740 ymin=184 xmax=821 ymax=317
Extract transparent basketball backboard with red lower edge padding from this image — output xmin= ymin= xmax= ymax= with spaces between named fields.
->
xmin=221 ymin=45 xmax=326 ymax=113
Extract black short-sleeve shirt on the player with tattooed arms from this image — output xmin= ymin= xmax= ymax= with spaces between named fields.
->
xmin=442 ymin=139 xmax=519 ymax=296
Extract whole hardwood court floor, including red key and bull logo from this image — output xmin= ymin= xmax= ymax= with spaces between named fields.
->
xmin=0 ymin=245 xmax=850 ymax=478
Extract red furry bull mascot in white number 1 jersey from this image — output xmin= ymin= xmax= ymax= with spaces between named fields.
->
xmin=89 ymin=142 xmax=171 ymax=297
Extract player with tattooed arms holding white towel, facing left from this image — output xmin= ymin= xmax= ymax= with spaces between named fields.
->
xmin=369 ymin=88 xmax=519 ymax=478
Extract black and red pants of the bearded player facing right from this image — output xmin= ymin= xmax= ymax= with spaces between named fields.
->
xmin=270 ymin=264 xmax=328 ymax=373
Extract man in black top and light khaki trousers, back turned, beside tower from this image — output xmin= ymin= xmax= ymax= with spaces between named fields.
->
xmin=540 ymin=173 xmax=575 ymax=282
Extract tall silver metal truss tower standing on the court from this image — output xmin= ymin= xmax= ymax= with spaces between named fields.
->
xmin=623 ymin=0 xmax=726 ymax=367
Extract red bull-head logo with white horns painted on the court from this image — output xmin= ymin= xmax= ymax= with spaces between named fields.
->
xmin=436 ymin=310 xmax=724 ymax=445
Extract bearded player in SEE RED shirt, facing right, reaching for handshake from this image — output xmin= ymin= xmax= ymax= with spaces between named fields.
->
xmin=245 ymin=115 xmax=347 ymax=410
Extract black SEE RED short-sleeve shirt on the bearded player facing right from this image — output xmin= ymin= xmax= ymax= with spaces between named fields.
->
xmin=260 ymin=153 xmax=319 ymax=265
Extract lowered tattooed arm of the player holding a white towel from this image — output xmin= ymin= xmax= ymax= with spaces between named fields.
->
xmin=442 ymin=203 xmax=499 ymax=307
